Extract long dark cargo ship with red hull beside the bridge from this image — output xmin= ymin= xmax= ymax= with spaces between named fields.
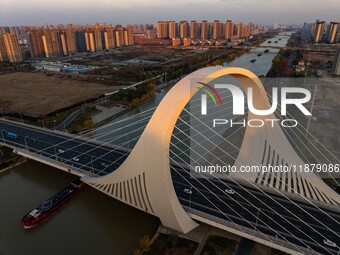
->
xmin=22 ymin=179 xmax=85 ymax=229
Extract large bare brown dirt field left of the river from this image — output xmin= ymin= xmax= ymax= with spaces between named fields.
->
xmin=0 ymin=72 xmax=117 ymax=115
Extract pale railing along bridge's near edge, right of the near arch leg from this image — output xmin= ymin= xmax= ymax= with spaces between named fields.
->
xmin=182 ymin=205 xmax=319 ymax=255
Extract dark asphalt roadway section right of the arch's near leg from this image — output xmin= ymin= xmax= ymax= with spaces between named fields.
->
xmin=172 ymin=167 xmax=340 ymax=254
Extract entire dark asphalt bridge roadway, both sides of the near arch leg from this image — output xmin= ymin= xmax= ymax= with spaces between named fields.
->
xmin=0 ymin=120 xmax=340 ymax=254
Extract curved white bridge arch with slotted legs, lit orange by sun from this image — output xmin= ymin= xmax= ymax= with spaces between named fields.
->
xmin=83 ymin=67 xmax=340 ymax=233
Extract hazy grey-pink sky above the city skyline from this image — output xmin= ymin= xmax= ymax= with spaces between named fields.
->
xmin=0 ymin=0 xmax=340 ymax=26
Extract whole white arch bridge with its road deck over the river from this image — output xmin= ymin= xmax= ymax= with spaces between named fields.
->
xmin=0 ymin=67 xmax=340 ymax=254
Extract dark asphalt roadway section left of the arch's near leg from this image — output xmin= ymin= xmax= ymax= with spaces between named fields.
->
xmin=0 ymin=120 xmax=128 ymax=176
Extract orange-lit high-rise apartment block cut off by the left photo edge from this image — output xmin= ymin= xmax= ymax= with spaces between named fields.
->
xmin=0 ymin=33 xmax=23 ymax=62
